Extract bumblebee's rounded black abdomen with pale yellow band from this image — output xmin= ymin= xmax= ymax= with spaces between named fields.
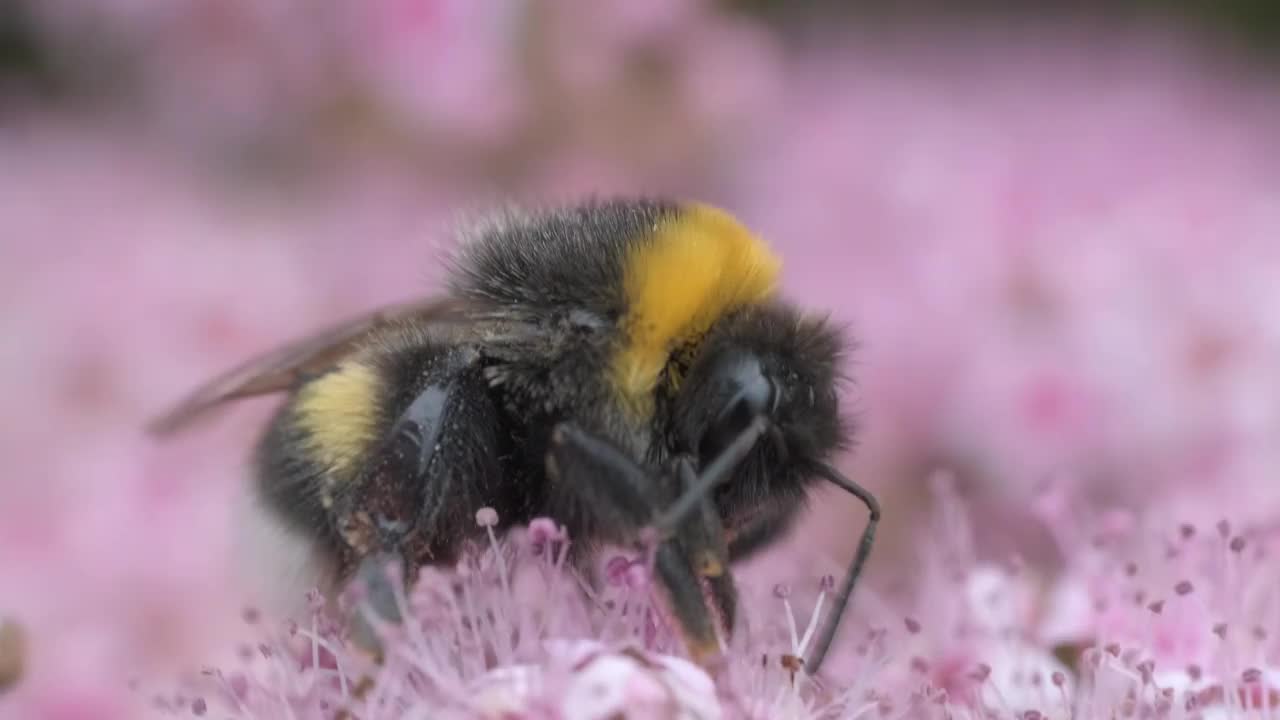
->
xmin=256 ymin=329 xmax=530 ymax=575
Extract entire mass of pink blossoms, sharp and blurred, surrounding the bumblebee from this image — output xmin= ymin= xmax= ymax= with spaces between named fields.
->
xmin=0 ymin=0 xmax=1280 ymax=720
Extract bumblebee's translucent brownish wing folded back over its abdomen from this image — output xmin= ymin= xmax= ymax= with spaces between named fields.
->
xmin=147 ymin=297 xmax=470 ymax=436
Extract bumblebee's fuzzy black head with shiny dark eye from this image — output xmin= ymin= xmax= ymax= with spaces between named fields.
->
xmin=671 ymin=304 xmax=852 ymax=512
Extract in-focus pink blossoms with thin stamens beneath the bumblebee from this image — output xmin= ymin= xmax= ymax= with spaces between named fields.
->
xmin=127 ymin=474 xmax=1280 ymax=720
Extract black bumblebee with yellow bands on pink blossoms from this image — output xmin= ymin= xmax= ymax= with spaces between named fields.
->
xmin=145 ymin=199 xmax=879 ymax=673
